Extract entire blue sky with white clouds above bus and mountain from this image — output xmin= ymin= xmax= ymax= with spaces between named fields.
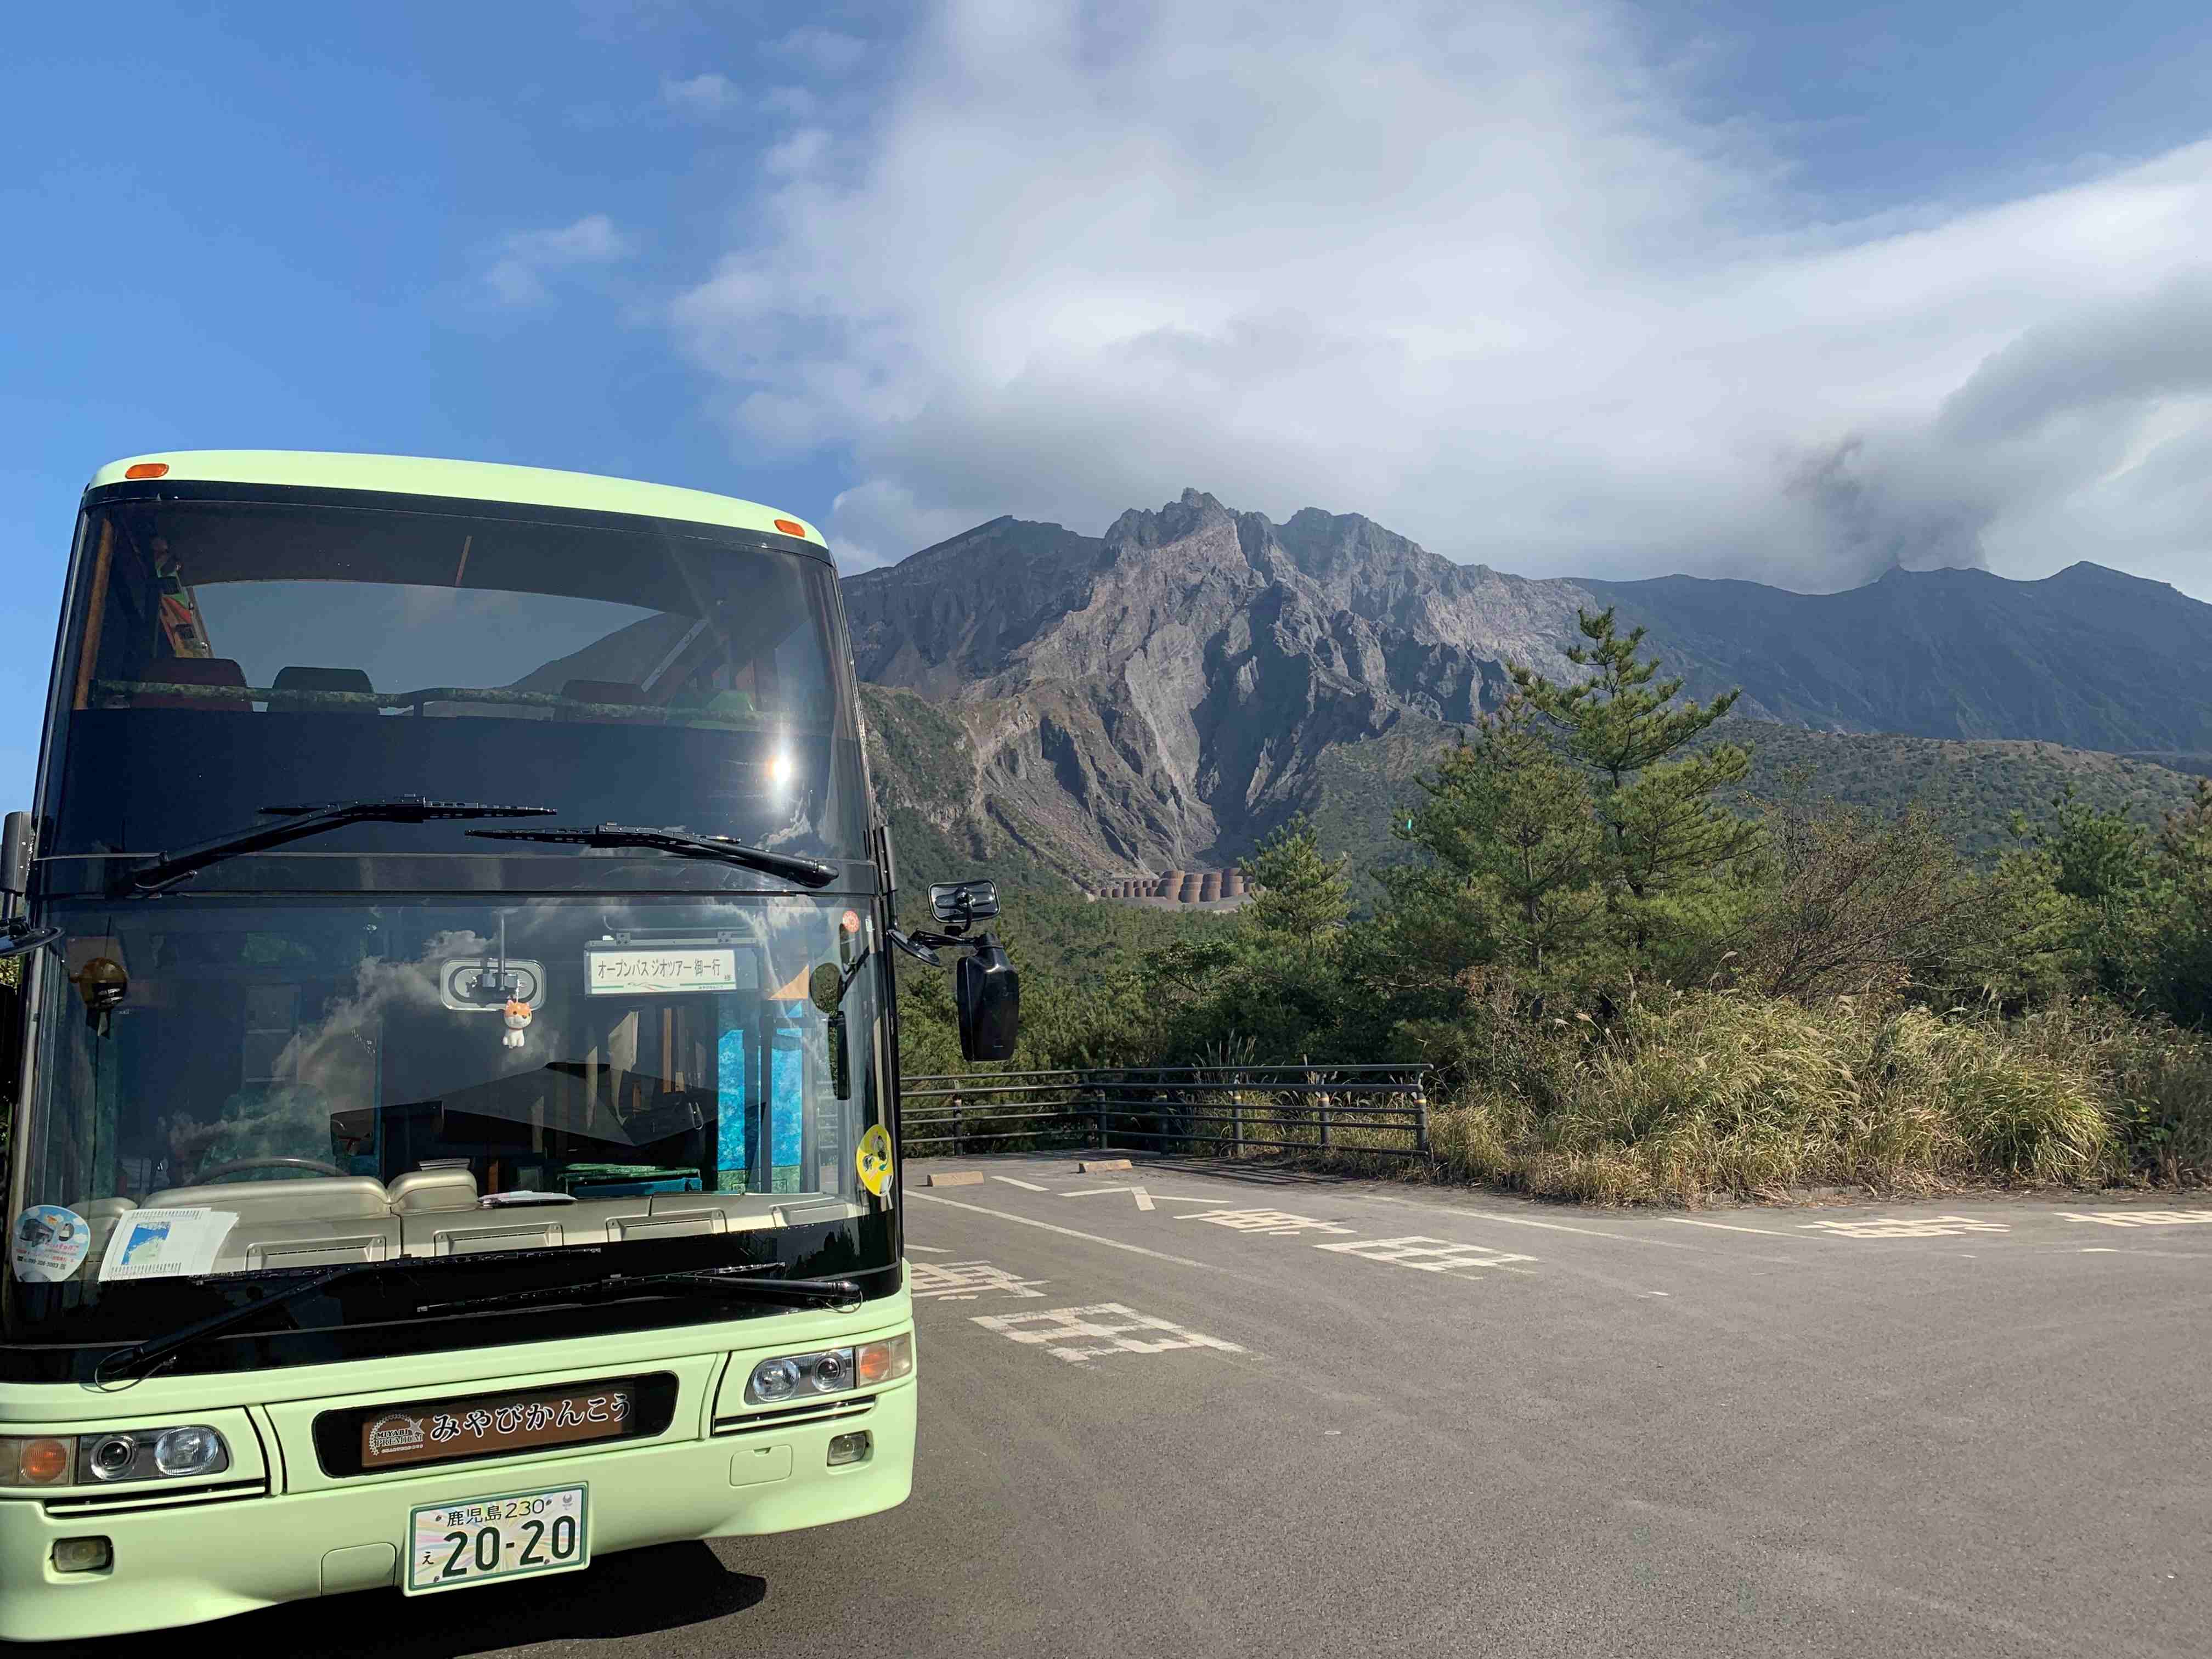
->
xmin=0 ymin=0 xmax=2212 ymax=801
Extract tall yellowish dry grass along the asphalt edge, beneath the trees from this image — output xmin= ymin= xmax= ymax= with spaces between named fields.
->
xmin=1429 ymin=993 xmax=2212 ymax=1205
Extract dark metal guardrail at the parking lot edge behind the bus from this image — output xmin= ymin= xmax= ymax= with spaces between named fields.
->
xmin=900 ymin=1064 xmax=1429 ymax=1157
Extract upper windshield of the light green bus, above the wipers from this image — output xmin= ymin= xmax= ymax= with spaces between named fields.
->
xmin=40 ymin=491 xmax=867 ymax=891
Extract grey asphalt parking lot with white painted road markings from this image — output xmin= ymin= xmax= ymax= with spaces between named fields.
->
xmin=56 ymin=1157 xmax=2212 ymax=1659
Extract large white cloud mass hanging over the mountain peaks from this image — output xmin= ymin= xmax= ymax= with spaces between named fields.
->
xmin=673 ymin=0 xmax=2212 ymax=595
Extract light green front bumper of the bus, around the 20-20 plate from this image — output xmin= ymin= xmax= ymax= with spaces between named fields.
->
xmin=0 ymin=1383 xmax=916 ymax=1641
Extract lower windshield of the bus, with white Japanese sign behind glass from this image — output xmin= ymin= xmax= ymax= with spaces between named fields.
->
xmin=9 ymin=896 xmax=891 ymax=1371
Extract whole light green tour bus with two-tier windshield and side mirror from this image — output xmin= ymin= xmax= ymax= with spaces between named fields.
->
xmin=0 ymin=452 xmax=1018 ymax=1641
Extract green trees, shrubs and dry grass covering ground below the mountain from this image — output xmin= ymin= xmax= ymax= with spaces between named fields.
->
xmin=878 ymin=613 xmax=2212 ymax=1203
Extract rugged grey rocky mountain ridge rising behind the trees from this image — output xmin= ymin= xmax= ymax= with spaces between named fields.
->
xmin=843 ymin=489 xmax=2212 ymax=881
